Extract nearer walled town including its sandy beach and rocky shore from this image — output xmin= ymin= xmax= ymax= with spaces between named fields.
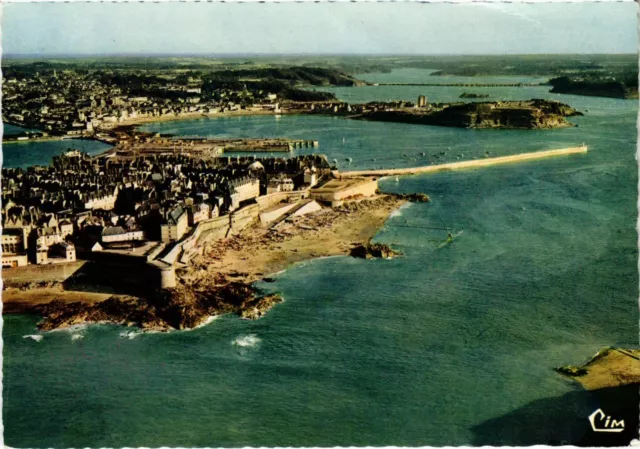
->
xmin=2 ymin=140 xmax=422 ymax=330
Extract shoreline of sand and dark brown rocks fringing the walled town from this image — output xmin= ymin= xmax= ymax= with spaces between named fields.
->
xmin=9 ymin=194 xmax=416 ymax=332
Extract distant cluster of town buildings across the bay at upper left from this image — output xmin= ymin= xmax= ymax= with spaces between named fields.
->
xmin=2 ymin=69 xmax=279 ymax=136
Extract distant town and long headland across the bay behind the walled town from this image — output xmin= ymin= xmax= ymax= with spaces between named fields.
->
xmin=2 ymin=66 xmax=581 ymax=141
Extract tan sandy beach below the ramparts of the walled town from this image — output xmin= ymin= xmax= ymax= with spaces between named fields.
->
xmin=180 ymin=195 xmax=406 ymax=283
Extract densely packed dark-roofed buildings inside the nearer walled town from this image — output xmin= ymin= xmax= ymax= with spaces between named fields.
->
xmin=2 ymin=150 xmax=330 ymax=267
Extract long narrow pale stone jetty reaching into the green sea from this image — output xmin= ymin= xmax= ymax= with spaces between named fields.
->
xmin=335 ymin=145 xmax=587 ymax=178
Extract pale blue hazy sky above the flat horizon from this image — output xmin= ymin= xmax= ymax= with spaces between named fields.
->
xmin=2 ymin=2 xmax=638 ymax=57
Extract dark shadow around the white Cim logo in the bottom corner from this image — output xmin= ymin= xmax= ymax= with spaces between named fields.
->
xmin=472 ymin=385 xmax=640 ymax=447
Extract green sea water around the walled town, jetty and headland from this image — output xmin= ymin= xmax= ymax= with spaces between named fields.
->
xmin=3 ymin=68 xmax=638 ymax=447
